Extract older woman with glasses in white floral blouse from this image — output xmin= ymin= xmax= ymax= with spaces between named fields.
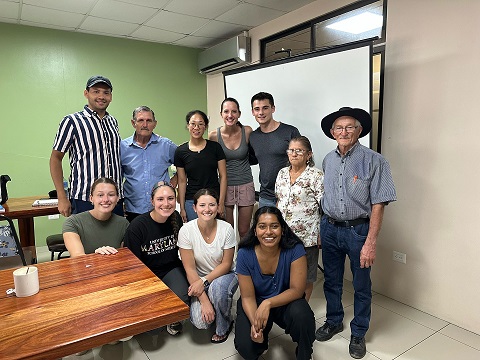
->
xmin=275 ymin=136 xmax=323 ymax=301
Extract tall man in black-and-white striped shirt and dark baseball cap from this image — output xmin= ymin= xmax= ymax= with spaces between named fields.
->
xmin=50 ymin=75 xmax=123 ymax=216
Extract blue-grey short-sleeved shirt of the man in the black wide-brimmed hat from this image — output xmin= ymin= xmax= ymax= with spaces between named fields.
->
xmin=322 ymin=142 xmax=397 ymax=221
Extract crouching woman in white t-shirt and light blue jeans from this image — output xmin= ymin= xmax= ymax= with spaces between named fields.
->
xmin=178 ymin=189 xmax=238 ymax=344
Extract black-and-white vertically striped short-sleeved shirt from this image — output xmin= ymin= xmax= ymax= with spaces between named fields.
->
xmin=53 ymin=105 xmax=123 ymax=201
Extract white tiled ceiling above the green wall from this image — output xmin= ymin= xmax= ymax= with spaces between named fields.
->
xmin=0 ymin=0 xmax=315 ymax=48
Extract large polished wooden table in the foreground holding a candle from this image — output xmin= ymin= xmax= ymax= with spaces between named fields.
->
xmin=0 ymin=248 xmax=189 ymax=360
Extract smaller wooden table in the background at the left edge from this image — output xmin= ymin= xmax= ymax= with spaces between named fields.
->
xmin=3 ymin=196 xmax=58 ymax=258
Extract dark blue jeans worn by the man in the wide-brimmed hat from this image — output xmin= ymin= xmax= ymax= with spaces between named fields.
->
xmin=320 ymin=216 xmax=372 ymax=337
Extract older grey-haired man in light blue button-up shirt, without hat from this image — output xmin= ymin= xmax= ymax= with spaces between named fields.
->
xmin=120 ymin=106 xmax=177 ymax=221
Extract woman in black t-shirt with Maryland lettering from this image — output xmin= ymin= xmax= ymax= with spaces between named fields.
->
xmin=124 ymin=181 xmax=190 ymax=335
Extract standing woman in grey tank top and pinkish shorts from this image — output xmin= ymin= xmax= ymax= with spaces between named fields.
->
xmin=208 ymin=98 xmax=255 ymax=238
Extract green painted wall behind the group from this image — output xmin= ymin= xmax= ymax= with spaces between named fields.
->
xmin=0 ymin=23 xmax=207 ymax=246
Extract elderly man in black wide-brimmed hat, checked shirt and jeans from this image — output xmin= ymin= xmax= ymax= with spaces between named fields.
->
xmin=315 ymin=107 xmax=396 ymax=359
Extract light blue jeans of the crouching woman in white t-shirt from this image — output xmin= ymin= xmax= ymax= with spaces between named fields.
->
xmin=190 ymin=272 xmax=238 ymax=336
